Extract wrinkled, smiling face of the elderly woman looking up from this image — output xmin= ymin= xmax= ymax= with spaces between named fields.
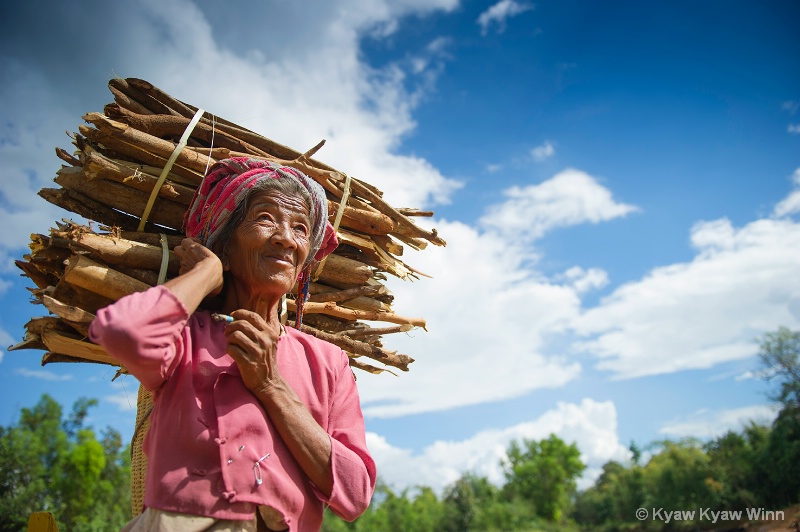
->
xmin=224 ymin=190 xmax=311 ymax=295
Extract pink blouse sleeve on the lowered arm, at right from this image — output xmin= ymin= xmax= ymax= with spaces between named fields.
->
xmin=315 ymin=355 xmax=377 ymax=521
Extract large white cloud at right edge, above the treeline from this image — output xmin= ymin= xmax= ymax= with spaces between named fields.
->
xmin=575 ymin=215 xmax=800 ymax=378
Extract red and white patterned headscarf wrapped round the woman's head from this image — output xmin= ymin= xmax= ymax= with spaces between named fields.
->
xmin=183 ymin=157 xmax=338 ymax=266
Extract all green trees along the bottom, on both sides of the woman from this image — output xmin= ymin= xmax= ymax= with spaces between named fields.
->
xmin=0 ymin=328 xmax=800 ymax=532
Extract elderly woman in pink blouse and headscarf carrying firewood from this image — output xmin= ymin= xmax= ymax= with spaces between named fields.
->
xmin=90 ymin=158 xmax=376 ymax=531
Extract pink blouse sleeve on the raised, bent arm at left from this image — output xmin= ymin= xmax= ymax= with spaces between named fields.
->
xmin=89 ymin=286 xmax=189 ymax=391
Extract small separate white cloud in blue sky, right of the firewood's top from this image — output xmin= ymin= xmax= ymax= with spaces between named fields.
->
xmin=480 ymin=169 xmax=638 ymax=241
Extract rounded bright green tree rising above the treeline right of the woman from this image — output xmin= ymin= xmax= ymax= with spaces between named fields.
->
xmin=504 ymin=434 xmax=586 ymax=522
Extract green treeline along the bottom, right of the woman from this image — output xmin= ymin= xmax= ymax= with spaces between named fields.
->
xmin=323 ymin=328 xmax=800 ymax=532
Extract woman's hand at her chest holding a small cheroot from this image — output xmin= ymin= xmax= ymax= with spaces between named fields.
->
xmin=225 ymin=310 xmax=281 ymax=392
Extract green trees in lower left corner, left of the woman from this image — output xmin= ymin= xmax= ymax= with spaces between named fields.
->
xmin=0 ymin=394 xmax=130 ymax=531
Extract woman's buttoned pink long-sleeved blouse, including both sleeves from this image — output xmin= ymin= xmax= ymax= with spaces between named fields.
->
xmin=89 ymin=286 xmax=376 ymax=530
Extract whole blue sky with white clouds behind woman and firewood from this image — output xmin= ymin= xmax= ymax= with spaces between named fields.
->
xmin=0 ymin=0 xmax=800 ymax=489
